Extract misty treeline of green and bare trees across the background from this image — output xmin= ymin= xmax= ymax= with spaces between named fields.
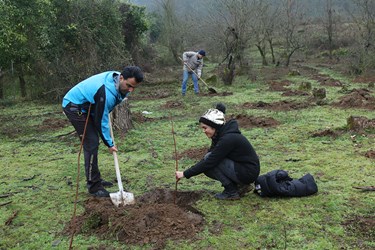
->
xmin=0 ymin=0 xmax=375 ymax=100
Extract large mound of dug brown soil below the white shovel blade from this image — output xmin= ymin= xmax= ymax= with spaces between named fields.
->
xmin=64 ymin=189 xmax=204 ymax=249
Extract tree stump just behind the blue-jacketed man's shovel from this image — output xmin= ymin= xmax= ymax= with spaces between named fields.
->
xmin=112 ymin=98 xmax=134 ymax=133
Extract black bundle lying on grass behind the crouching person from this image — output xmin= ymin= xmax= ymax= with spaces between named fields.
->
xmin=255 ymin=170 xmax=318 ymax=197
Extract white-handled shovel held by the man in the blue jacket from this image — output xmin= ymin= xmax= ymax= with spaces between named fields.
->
xmin=108 ymin=115 xmax=135 ymax=207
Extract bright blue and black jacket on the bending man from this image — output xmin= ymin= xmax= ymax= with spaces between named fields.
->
xmin=62 ymin=71 xmax=126 ymax=147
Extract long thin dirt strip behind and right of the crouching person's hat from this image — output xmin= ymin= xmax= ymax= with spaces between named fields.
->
xmin=242 ymin=101 xmax=311 ymax=111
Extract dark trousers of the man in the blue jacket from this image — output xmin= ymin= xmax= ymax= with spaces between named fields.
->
xmin=64 ymin=103 xmax=103 ymax=193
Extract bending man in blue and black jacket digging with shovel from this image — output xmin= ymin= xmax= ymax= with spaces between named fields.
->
xmin=62 ymin=66 xmax=143 ymax=197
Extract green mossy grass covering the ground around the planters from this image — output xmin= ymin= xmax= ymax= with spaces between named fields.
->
xmin=0 ymin=61 xmax=375 ymax=249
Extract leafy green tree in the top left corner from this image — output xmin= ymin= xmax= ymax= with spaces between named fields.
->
xmin=0 ymin=0 xmax=50 ymax=97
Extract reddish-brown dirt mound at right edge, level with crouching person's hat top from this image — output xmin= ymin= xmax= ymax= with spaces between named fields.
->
xmin=333 ymin=89 xmax=375 ymax=110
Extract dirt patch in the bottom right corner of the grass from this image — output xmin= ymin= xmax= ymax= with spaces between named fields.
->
xmin=343 ymin=215 xmax=375 ymax=241
